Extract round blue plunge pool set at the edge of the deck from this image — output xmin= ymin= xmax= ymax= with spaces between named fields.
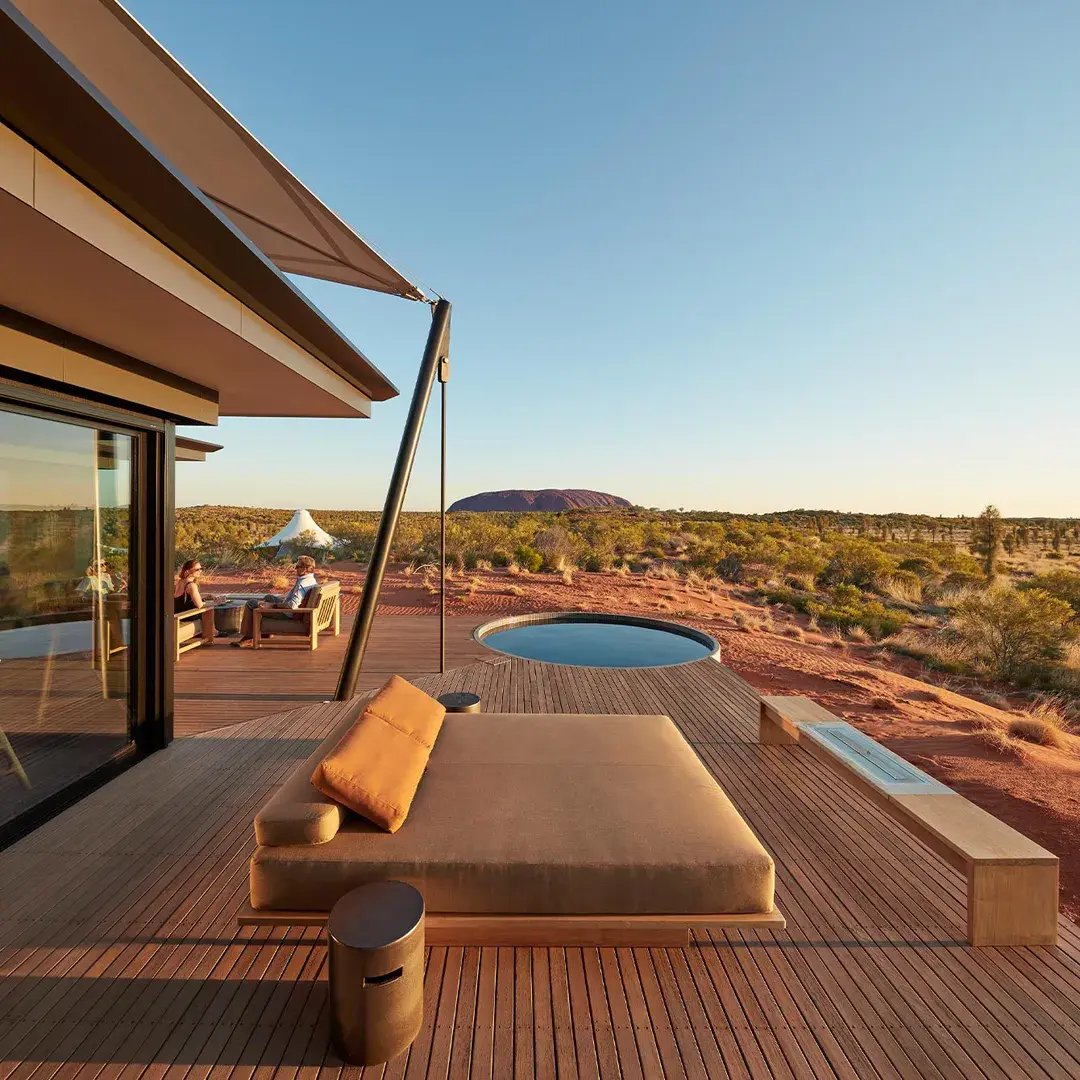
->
xmin=473 ymin=611 xmax=720 ymax=667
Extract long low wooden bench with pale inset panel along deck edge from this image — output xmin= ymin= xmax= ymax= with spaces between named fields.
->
xmin=759 ymin=697 xmax=1058 ymax=945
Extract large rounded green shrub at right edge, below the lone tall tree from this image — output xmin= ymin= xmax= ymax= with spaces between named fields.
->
xmin=950 ymin=586 xmax=1076 ymax=678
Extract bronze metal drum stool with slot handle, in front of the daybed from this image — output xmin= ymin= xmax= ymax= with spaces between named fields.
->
xmin=326 ymin=881 xmax=423 ymax=1065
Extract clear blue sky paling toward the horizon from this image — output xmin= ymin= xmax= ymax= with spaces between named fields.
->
xmin=137 ymin=0 xmax=1080 ymax=515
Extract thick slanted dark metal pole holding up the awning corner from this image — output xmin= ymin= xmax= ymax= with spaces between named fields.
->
xmin=334 ymin=300 xmax=450 ymax=701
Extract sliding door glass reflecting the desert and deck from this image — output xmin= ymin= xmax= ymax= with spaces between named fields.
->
xmin=0 ymin=411 xmax=135 ymax=825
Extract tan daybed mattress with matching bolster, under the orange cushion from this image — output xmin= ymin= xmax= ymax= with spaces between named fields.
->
xmin=251 ymin=714 xmax=773 ymax=915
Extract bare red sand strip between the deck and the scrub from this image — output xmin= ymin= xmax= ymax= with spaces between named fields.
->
xmin=206 ymin=563 xmax=1080 ymax=918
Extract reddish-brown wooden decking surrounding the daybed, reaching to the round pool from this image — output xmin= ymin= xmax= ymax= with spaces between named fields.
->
xmin=0 ymin=650 xmax=1080 ymax=1080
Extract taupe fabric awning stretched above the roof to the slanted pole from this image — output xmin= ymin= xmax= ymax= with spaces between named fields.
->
xmin=13 ymin=0 xmax=427 ymax=300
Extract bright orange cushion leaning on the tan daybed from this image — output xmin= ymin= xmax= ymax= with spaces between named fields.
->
xmin=311 ymin=675 xmax=446 ymax=833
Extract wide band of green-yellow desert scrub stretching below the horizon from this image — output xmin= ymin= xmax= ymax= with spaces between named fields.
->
xmin=176 ymin=507 xmax=1080 ymax=708
